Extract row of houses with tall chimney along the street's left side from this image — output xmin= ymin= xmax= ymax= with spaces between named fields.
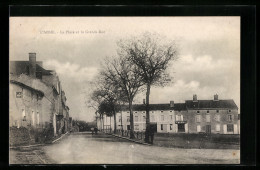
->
xmin=9 ymin=53 xmax=69 ymax=135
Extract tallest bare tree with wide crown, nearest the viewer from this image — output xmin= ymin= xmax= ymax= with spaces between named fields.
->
xmin=118 ymin=32 xmax=177 ymax=142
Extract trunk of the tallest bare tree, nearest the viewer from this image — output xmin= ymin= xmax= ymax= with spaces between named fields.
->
xmin=144 ymin=84 xmax=151 ymax=143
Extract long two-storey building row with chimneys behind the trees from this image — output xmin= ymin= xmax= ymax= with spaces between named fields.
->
xmin=100 ymin=95 xmax=240 ymax=134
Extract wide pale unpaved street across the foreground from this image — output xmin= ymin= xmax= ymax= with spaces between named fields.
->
xmin=10 ymin=133 xmax=240 ymax=164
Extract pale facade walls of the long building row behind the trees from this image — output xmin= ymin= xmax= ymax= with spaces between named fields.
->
xmin=100 ymin=109 xmax=240 ymax=134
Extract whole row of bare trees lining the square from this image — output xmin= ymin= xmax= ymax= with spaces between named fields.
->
xmin=89 ymin=32 xmax=177 ymax=142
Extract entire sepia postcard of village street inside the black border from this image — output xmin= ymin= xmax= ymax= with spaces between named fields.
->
xmin=9 ymin=16 xmax=243 ymax=165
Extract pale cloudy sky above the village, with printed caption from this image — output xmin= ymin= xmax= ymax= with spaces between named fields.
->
xmin=9 ymin=16 xmax=240 ymax=121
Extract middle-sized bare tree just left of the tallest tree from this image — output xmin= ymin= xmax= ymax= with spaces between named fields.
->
xmin=101 ymin=57 xmax=143 ymax=139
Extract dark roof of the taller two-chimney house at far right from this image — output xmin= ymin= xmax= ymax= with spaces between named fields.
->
xmin=185 ymin=100 xmax=238 ymax=109
